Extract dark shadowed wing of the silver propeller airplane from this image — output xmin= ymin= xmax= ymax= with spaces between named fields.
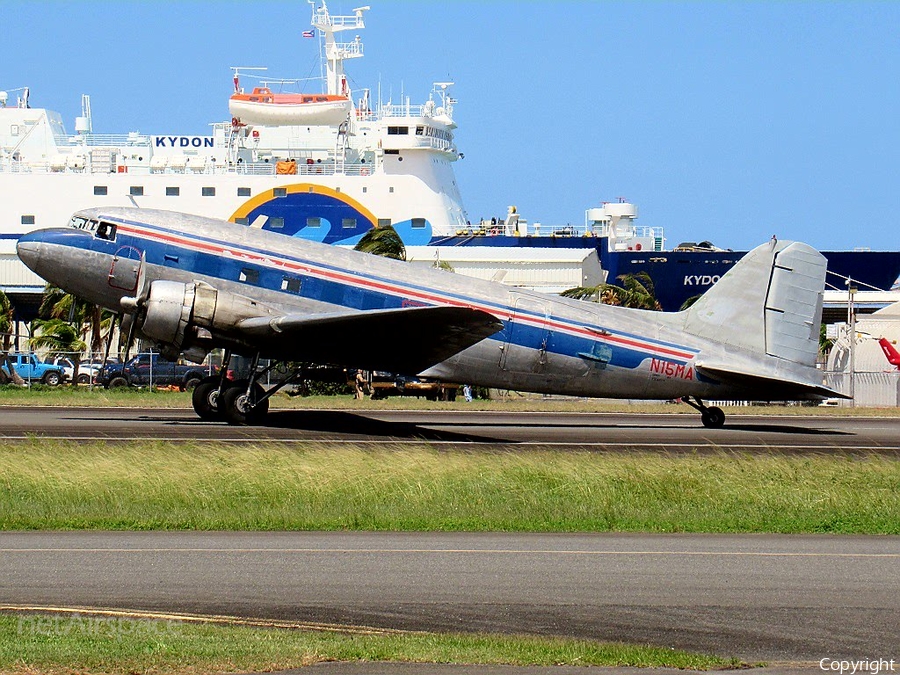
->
xmin=236 ymin=307 xmax=503 ymax=375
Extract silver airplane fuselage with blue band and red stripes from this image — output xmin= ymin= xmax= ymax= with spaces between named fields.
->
xmin=18 ymin=209 xmax=824 ymax=399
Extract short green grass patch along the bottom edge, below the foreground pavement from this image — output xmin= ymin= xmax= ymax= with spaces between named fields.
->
xmin=0 ymin=615 xmax=740 ymax=674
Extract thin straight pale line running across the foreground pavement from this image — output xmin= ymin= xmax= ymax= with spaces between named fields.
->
xmin=0 ymin=547 xmax=900 ymax=558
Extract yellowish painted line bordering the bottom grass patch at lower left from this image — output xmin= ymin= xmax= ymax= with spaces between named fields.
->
xmin=0 ymin=605 xmax=414 ymax=635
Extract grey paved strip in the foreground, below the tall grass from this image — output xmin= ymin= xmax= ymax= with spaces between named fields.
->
xmin=0 ymin=532 xmax=900 ymax=662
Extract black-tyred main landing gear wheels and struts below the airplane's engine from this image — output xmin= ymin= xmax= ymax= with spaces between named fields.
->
xmin=191 ymin=351 xmax=303 ymax=425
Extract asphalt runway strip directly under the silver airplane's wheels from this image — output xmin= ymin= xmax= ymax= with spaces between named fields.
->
xmin=0 ymin=407 xmax=900 ymax=457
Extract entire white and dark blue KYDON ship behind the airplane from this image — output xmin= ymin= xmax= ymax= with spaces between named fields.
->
xmin=0 ymin=2 xmax=900 ymax=317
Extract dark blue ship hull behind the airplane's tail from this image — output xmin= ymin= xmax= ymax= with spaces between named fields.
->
xmin=430 ymin=235 xmax=900 ymax=312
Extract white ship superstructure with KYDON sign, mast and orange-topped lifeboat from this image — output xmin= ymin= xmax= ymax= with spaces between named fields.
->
xmin=0 ymin=2 xmax=466 ymax=312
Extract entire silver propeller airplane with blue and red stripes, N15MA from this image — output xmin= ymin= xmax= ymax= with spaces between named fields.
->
xmin=17 ymin=207 xmax=846 ymax=427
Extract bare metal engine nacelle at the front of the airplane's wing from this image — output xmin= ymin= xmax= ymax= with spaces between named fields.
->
xmin=137 ymin=279 xmax=279 ymax=361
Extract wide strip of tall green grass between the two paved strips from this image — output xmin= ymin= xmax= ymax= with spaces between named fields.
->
xmin=0 ymin=439 xmax=900 ymax=534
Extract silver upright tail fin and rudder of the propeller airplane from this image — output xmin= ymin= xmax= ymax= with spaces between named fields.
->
xmin=681 ymin=238 xmax=844 ymax=396
